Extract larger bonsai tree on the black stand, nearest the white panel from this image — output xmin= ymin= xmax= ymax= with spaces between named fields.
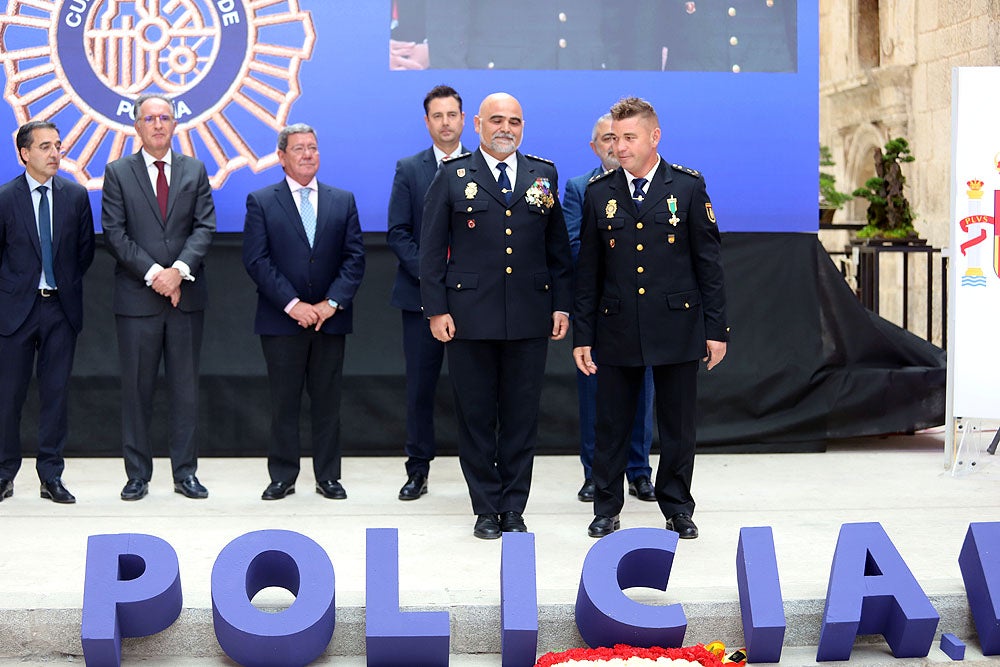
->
xmin=854 ymin=137 xmax=917 ymax=239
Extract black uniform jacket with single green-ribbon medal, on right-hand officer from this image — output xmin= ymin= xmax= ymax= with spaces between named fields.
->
xmin=573 ymin=160 xmax=728 ymax=366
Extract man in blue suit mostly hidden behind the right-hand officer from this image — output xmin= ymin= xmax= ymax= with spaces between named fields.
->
xmin=563 ymin=113 xmax=656 ymax=503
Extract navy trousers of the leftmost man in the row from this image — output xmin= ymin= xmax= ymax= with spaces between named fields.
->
xmin=0 ymin=295 xmax=76 ymax=482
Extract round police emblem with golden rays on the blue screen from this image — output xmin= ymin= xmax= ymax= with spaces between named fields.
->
xmin=0 ymin=0 xmax=316 ymax=190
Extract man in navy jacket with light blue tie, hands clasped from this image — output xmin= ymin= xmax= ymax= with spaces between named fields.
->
xmin=243 ymin=123 xmax=365 ymax=500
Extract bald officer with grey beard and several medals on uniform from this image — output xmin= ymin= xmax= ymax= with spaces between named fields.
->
xmin=420 ymin=93 xmax=572 ymax=539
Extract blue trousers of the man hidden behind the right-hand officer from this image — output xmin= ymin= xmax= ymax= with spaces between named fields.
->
xmin=576 ymin=360 xmax=653 ymax=482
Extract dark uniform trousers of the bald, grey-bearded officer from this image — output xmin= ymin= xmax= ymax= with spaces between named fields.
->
xmin=446 ymin=338 xmax=548 ymax=514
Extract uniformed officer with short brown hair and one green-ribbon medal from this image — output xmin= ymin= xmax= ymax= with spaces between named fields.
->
xmin=573 ymin=97 xmax=728 ymax=539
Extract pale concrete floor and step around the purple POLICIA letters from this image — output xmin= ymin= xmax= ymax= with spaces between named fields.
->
xmin=0 ymin=433 xmax=1000 ymax=667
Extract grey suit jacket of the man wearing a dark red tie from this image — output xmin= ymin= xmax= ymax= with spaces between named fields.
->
xmin=101 ymin=151 xmax=215 ymax=317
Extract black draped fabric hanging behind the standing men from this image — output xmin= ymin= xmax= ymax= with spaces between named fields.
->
xmin=22 ymin=233 xmax=945 ymax=456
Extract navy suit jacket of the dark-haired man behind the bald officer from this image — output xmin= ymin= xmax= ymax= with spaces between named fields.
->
xmin=386 ymin=148 xmax=437 ymax=311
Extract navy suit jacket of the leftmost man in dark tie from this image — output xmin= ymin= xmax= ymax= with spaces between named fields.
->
xmin=0 ymin=174 xmax=94 ymax=336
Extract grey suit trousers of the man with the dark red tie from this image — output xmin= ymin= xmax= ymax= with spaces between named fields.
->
xmin=115 ymin=308 xmax=205 ymax=482
